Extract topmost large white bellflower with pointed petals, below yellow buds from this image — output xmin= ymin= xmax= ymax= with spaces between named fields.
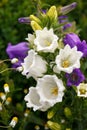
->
xmin=34 ymin=27 xmax=58 ymax=52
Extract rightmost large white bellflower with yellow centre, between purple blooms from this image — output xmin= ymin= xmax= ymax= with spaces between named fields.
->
xmin=54 ymin=45 xmax=82 ymax=73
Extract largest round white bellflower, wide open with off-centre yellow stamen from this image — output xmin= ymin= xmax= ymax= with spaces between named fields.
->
xmin=36 ymin=75 xmax=65 ymax=106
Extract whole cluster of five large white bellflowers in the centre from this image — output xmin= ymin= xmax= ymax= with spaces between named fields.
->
xmin=22 ymin=27 xmax=82 ymax=111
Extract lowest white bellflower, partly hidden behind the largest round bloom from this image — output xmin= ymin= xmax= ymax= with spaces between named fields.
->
xmin=24 ymin=87 xmax=50 ymax=111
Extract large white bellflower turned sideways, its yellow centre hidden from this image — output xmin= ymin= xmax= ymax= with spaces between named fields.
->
xmin=22 ymin=50 xmax=47 ymax=79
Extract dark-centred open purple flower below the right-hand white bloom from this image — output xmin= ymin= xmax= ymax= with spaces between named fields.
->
xmin=66 ymin=69 xmax=85 ymax=86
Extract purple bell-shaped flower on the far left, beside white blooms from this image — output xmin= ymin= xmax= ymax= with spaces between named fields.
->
xmin=6 ymin=42 xmax=29 ymax=68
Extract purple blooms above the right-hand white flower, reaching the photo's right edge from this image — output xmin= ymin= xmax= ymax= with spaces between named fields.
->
xmin=63 ymin=33 xmax=87 ymax=57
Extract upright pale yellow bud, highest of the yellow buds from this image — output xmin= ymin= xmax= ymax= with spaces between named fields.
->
xmin=47 ymin=6 xmax=57 ymax=19
